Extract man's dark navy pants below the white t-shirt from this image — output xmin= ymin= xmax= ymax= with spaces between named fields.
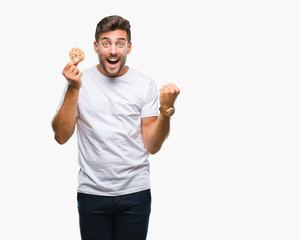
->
xmin=77 ymin=190 xmax=151 ymax=240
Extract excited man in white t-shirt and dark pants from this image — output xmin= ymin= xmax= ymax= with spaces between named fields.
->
xmin=52 ymin=16 xmax=180 ymax=240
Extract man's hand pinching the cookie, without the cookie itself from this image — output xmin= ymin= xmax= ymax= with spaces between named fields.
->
xmin=62 ymin=59 xmax=82 ymax=89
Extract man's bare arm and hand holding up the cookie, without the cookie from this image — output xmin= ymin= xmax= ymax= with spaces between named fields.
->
xmin=52 ymin=61 xmax=82 ymax=144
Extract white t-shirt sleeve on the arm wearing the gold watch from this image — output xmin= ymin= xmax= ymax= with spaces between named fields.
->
xmin=141 ymin=81 xmax=159 ymax=118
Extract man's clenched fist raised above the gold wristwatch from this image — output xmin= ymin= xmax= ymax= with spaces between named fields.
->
xmin=159 ymin=83 xmax=180 ymax=109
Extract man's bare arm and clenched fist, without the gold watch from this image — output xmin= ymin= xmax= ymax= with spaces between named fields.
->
xmin=142 ymin=84 xmax=180 ymax=154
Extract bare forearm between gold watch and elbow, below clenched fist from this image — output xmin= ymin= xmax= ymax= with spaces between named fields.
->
xmin=144 ymin=114 xmax=170 ymax=154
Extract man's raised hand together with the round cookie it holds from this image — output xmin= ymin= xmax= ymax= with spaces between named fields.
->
xmin=62 ymin=48 xmax=85 ymax=89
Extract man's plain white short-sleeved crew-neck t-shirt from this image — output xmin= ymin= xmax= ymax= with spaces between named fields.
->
xmin=59 ymin=65 xmax=158 ymax=196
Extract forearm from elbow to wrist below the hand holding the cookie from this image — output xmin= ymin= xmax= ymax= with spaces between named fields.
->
xmin=52 ymin=86 xmax=79 ymax=144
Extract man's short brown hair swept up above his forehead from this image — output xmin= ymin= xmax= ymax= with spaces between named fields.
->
xmin=95 ymin=15 xmax=131 ymax=43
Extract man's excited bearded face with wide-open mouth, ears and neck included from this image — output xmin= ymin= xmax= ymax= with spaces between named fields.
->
xmin=94 ymin=30 xmax=131 ymax=77
